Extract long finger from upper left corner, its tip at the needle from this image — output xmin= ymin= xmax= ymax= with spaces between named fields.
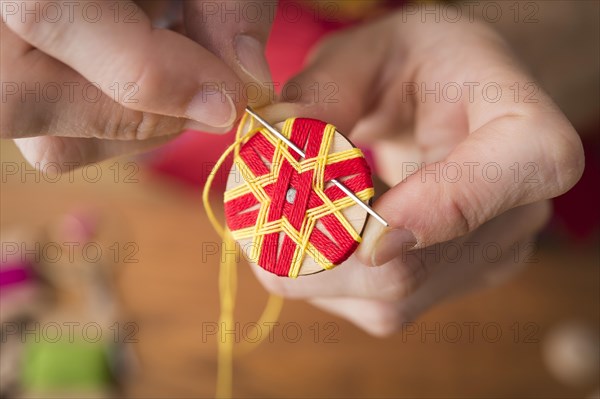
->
xmin=1 ymin=0 xmax=246 ymax=127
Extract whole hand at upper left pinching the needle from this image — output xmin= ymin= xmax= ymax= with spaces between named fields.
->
xmin=0 ymin=0 xmax=273 ymax=167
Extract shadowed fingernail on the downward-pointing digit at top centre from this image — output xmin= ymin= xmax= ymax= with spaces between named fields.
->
xmin=234 ymin=35 xmax=271 ymax=86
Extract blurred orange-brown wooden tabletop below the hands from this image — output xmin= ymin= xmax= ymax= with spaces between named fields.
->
xmin=0 ymin=142 xmax=600 ymax=398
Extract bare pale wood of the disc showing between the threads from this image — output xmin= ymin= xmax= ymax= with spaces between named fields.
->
xmin=226 ymin=117 xmax=368 ymax=276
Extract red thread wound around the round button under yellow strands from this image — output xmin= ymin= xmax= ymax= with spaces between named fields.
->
xmin=225 ymin=118 xmax=373 ymax=276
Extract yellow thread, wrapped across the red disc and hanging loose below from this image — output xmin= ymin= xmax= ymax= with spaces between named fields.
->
xmin=202 ymin=114 xmax=374 ymax=398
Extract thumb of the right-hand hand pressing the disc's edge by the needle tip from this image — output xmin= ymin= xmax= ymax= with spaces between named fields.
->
xmin=357 ymin=104 xmax=583 ymax=266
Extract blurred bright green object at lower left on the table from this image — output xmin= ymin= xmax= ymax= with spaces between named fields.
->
xmin=22 ymin=340 xmax=113 ymax=393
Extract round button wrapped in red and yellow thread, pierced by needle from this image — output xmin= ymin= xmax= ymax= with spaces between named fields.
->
xmin=224 ymin=118 xmax=374 ymax=277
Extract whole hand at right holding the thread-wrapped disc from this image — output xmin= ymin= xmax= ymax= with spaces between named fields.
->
xmin=254 ymin=7 xmax=583 ymax=335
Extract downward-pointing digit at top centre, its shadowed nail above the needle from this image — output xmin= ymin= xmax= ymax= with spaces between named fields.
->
xmin=184 ymin=0 xmax=277 ymax=106
